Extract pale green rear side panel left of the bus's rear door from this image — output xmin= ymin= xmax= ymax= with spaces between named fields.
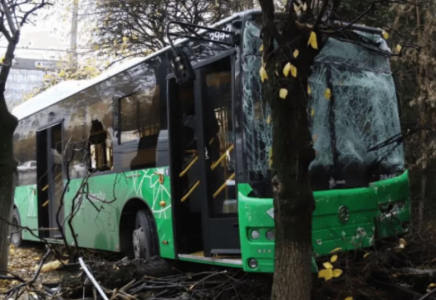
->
xmin=14 ymin=185 xmax=39 ymax=241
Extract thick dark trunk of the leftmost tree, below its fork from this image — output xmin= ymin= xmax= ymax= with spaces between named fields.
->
xmin=0 ymin=92 xmax=17 ymax=272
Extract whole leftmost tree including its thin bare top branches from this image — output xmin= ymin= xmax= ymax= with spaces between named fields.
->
xmin=0 ymin=0 xmax=49 ymax=271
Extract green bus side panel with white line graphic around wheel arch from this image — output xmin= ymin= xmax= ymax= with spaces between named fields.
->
xmin=65 ymin=168 xmax=175 ymax=258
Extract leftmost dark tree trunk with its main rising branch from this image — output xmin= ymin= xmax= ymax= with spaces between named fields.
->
xmin=0 ymin=36 xmax=20 ymax=272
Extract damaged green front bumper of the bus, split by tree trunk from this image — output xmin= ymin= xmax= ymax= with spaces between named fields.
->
xmin=238 ymin=171 xmax=410 ymax=272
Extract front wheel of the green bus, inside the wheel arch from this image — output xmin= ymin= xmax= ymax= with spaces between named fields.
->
xmin=133 ymin=210 xmax=152 ymax=259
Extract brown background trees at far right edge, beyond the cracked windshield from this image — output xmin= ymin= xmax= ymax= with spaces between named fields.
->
xmin=389 ymin=0 xmax=436 ymax=229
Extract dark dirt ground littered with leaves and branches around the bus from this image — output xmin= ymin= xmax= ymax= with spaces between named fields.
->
xmin=0 ymin=233 xmax=436 ymax=300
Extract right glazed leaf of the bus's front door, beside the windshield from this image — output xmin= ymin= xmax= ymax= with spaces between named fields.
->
xmin=194 ymin=56 xmax=240 ymax=256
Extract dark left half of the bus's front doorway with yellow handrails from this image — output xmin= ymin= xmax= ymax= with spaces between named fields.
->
xmin=168 ymin=78 xmax=205 ymax=254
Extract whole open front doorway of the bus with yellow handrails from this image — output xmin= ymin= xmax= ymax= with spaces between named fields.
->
xmin=168 ymin=52 xmax=240 ymax=257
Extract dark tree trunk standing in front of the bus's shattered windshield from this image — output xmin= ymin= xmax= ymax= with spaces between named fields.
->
xmin=259 ymin=0 xmax=319 ymax=300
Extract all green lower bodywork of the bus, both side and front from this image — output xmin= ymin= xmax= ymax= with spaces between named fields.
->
xmin=15 ymin=168 xmax=410 ymax=272
